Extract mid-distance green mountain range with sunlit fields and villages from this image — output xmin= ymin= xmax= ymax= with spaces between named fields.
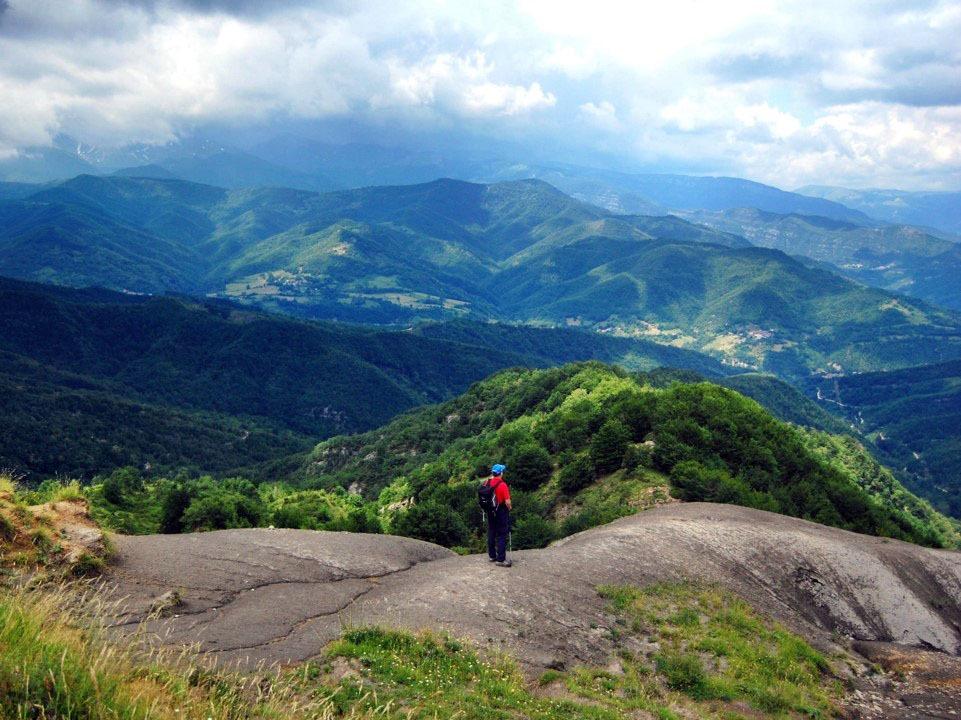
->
xmin=0 ymin=176 xmax=961 ymax=377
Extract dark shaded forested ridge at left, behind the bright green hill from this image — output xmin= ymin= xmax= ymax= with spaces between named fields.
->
xmin=0 ymin=278 xmax=725 ymax=479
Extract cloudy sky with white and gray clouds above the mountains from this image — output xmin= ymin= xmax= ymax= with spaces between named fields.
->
xmin=0 ymin=0 xmax=961 ymax=189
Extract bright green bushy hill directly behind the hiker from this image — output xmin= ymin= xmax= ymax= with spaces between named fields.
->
xmin=292 ymin=363 xmax=959 ymax=547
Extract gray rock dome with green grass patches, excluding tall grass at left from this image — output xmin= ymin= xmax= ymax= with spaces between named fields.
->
xmin=99 ymin=503 xmax=961 ymax=720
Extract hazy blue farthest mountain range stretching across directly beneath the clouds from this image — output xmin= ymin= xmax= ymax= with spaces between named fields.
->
xmin=0 ymin=133 xmax=928 ymax=225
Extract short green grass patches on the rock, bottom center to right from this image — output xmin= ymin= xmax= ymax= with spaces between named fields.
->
xmin=304 ymin=584 xmax=840 ymax=719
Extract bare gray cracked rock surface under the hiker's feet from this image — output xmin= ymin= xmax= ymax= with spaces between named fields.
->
xmin=108 ymin=503 xmax=961 ymax=671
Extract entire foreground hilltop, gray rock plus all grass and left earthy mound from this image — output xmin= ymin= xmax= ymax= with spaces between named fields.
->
xmin=0 ymin=490 xmax=961 ymax=720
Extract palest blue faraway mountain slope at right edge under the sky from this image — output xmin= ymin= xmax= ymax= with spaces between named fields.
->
xmin=797 ymin=185 xmax=961 ymax=236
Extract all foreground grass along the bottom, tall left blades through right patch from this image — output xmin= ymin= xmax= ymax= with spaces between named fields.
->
xmin=0 ymin=585 xmax=838 ymax=720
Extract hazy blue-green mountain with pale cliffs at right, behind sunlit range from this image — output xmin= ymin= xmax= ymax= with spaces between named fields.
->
xmin=681 ymin=208 xmax=961 ymax=310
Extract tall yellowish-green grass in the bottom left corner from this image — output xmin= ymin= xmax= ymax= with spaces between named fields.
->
xmin=0 ymin=589 xmax=344 ymax=720
